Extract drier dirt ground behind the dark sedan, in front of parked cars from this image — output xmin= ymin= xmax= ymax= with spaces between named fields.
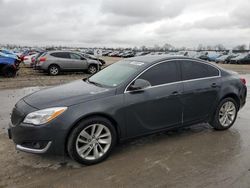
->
xmin=0 ymin=57 xmax=250 ymax=89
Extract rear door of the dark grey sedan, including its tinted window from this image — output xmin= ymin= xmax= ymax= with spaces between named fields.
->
xmin=180 ymin=60 xmax=221 ymax=123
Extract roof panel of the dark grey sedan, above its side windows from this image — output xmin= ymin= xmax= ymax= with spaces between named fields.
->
xmin=128 ymin=55 xmax=204 ymax=64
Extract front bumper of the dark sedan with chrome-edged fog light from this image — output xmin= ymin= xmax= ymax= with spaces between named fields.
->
xmin=8 ymin=123 xmax=65 ymax=155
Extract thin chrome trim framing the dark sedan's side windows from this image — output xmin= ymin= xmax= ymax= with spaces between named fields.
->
xmin=124 ymin=59 xmax=221 ymax=93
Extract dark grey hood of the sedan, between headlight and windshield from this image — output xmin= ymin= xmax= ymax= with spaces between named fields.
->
xmin=23 ymin=80 xmax=115 ymax=109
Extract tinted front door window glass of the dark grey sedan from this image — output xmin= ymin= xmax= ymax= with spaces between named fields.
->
xmin=139 ymin=61 xmax=180 ymax=86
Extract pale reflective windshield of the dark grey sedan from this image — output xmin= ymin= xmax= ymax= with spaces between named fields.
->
xmin=88 ymin=60 xmax=145 ymax=87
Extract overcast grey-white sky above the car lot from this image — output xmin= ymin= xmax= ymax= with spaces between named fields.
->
xmin=0 ymin=0 xmax=250 ymax=48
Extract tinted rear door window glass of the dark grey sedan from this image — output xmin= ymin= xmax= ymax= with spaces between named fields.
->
xmin=181 ymin=61 xmax=219 ymax=80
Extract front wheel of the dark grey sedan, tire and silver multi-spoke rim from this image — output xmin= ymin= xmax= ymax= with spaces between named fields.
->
xmin=67 ymin=117 xmax=117 ymax=165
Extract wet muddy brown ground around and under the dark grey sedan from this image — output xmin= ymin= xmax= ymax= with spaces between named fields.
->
xmin=0 ymin=75 xmax=250 ymax=188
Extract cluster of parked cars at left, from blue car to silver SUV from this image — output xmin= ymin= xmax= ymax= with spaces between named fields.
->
xmin=0 ymin=50 xmax=106 ymax=77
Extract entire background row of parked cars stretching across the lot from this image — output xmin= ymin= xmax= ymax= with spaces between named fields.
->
xmin=0 ymin=49 xmax=250 ymax=77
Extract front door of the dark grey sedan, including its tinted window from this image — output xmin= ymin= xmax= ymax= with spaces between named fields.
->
xmin=124 ymin=61 xmax=183 ymax=136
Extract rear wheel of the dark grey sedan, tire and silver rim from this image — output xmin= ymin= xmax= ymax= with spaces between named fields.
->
xmin=210 ymin=97 xmax=239 ymax=130
